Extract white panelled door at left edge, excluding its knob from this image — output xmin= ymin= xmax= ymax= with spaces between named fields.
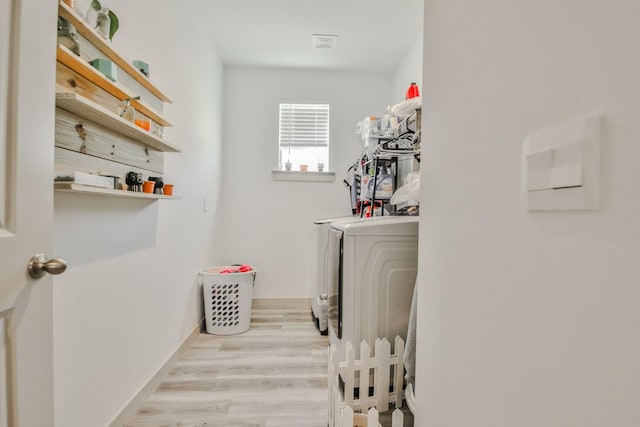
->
xmin=0 ymin=0 xmax=57 ymax=427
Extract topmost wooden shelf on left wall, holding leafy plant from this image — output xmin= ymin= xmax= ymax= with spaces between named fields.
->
xmin=58 ymin=0 xmax=171 ymax=103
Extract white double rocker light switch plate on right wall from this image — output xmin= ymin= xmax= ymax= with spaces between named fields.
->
xmin=522 ymin=114 xmax=602 ymax=211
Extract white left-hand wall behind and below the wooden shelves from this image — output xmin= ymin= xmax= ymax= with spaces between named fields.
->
xmin=54 ymin=0 xmax=223 ymax=427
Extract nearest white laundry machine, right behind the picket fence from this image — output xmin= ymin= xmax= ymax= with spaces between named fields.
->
xmin=328 ymin=216 xmax=419 ymax=359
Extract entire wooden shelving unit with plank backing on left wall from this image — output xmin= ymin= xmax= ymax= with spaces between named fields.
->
xmin=54 ymin=0 xmax=181 ymax=203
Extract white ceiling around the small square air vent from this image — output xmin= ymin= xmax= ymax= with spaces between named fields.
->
xmin=192 ymin=0 xmax=423 ymax=73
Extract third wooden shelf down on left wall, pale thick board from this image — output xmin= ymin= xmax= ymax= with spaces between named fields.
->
xmin=56 ymin=93 xmax=180 ymax=153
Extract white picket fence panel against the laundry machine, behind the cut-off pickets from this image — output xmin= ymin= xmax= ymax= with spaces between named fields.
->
xmin=329 ymin=336 xmax=404 ymax=427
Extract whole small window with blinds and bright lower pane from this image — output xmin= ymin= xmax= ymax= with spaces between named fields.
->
xmin=278 ymin=104 xmax=329 ymax=171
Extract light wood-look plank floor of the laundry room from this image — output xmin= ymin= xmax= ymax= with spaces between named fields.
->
xmin=125 ymin=307 xmax=413 ymax=427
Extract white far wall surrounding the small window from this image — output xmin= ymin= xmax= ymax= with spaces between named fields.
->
xmin=216 ymin=68 xmax=390 ymax=298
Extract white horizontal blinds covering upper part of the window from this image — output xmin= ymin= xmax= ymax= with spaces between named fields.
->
xmin=280 ymin=104 xmax=329 ymax=148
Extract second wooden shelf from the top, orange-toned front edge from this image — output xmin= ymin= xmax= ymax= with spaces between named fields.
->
xmin=57 ymin=44 xmax=171 ymax=127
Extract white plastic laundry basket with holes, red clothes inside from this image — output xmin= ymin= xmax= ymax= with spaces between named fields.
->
xmin=200 ymin=266 xmax=256 ymax=335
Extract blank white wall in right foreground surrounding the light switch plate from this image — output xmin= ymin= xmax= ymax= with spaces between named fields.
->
xmin=416 ymin=0 xmax=640 ymax=427
